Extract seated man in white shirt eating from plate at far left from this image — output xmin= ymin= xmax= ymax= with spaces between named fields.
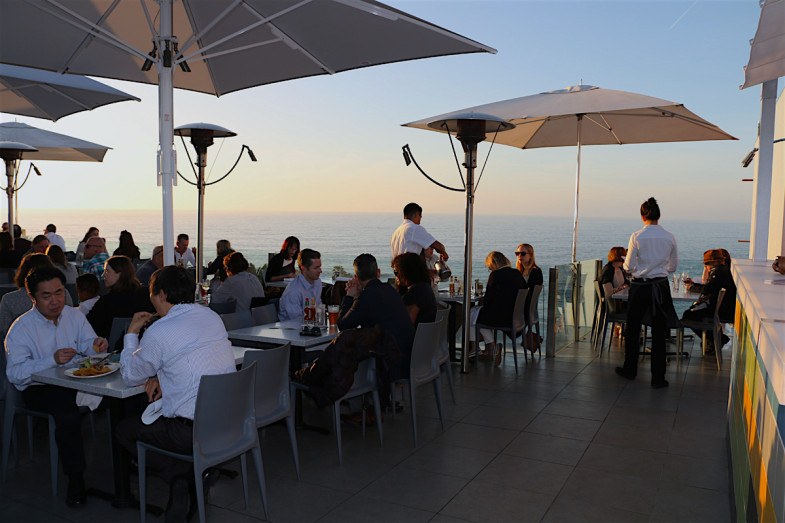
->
xmin=5 ymin=267 xmax=109 ymax=506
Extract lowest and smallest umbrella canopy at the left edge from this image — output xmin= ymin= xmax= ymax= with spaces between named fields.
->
xmin=0 ymin=122 xmax=111 ymax=162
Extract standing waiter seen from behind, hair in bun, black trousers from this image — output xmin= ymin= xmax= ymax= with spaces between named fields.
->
xmin=616 ymin=198 xmax=679 ymax=389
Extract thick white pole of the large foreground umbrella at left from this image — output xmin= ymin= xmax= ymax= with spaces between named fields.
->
xmin=156 ymin=0 xmax=176 ymax=265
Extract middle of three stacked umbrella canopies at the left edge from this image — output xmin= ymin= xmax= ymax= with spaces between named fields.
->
xmin=0 ymin=64 xmax=140 ymax=121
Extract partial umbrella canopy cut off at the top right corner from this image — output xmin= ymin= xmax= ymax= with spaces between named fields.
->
xmin=741 ymin=0 xmax=785 ymax=89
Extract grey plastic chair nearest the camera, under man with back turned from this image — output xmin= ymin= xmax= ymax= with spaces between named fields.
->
xmin=136 ymin=364 xmax=269 ymax=523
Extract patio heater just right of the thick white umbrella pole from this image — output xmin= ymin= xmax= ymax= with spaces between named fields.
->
xmin=174 ymin=123 xmax=256 ymax=284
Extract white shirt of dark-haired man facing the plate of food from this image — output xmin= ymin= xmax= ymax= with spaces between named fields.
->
xmin=5 ymin=305 xmax=96 ymax=390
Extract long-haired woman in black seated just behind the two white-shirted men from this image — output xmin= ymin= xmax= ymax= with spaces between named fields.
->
xmin=87 ymin=256 xmax=155 ymax=338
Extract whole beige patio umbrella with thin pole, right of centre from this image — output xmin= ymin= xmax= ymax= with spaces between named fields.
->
xmin=404 ymin=85 xmax=736 ymax=263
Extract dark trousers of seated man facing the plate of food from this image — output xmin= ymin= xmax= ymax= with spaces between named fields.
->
xmin=22 ymin=385 xmax=85 ymax=477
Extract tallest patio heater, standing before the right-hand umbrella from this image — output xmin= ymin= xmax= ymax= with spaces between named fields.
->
xmin=404 ymin=113 xmax=515 ymax=373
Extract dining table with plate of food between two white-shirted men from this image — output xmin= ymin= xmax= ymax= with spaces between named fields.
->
xmin=31 ymin=360 xmax=150 ymax=513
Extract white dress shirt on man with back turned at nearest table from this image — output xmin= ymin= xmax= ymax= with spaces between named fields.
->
xmin=120 ymin=303 xmax=235 ymax=422
